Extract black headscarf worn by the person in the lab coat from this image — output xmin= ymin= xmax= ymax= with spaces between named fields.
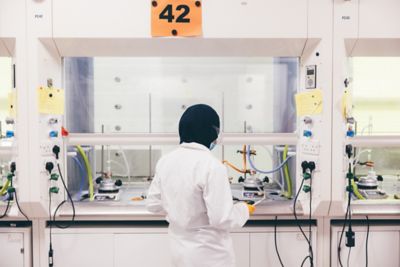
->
xmin=179 ymin=104 xmax=219 ymax=150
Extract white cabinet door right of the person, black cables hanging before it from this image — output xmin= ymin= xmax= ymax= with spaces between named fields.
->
xmin=250 ymin=230 xmax=317 ymax=267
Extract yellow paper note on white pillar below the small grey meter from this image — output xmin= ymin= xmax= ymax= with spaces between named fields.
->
xmin=295 ymin=89 xmax=323 ymax=117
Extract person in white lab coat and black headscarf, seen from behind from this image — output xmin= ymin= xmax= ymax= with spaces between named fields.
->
xmin=147 ymin=104 xmax=254 ymax=267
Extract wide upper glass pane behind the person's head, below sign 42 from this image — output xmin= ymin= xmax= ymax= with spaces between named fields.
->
xmin=64 ymin=57 xmax=298 ymax=133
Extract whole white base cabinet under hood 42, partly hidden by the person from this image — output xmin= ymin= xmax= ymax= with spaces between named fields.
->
xmin=46 ymin=227 xmax=317 ymax=267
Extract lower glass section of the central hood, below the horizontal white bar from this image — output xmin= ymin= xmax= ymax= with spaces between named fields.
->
xmin=67 ymin=145 xmax=296 ymax=201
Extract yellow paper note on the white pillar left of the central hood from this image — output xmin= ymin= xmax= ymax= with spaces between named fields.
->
xmin=37 ymin=87 xmax=65 ymax=115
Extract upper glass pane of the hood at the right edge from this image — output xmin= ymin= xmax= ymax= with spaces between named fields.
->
xmin=352 ymin=57 xmax=400 ymax=135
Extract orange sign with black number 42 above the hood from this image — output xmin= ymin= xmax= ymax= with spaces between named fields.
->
xmin=151 ymin=0 xmax=202 ymax=36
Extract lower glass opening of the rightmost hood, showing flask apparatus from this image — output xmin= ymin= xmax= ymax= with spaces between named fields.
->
xmin=355 ymin=148 xmax=400 ymax=199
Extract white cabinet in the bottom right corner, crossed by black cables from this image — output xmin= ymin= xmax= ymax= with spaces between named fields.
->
xmin=331 ymin=226 xmax=400 ymax=267
